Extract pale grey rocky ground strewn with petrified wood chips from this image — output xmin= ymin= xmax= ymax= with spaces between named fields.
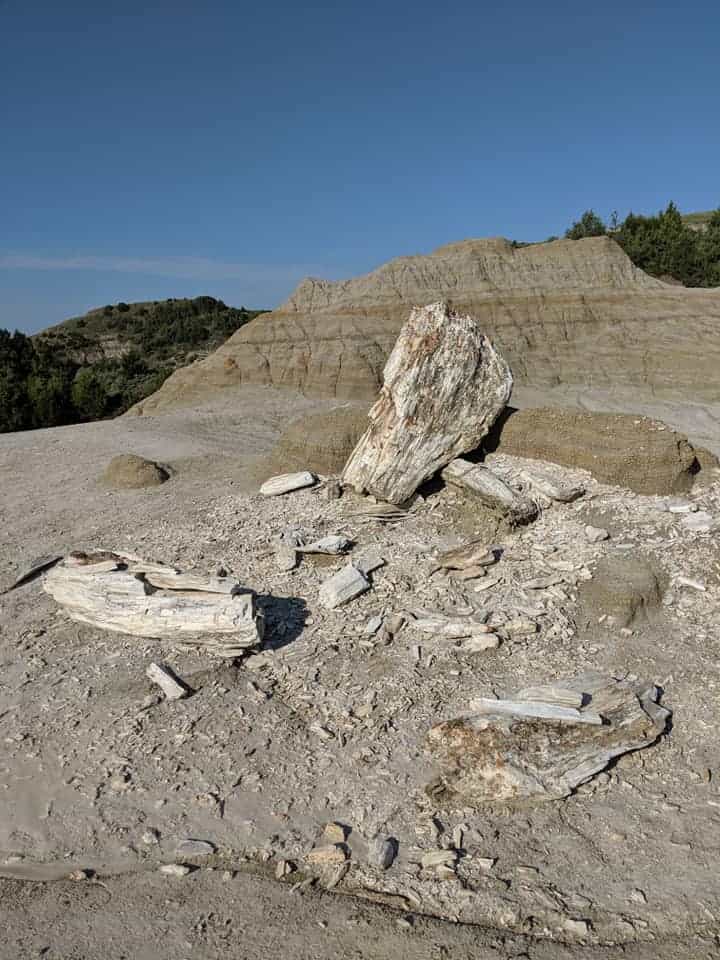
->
xmin=0 ymin=388 xmax=720 ymax=958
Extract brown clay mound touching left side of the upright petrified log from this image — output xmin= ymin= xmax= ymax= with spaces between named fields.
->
xmin=263 ymin=406 xmax=368 ymax=476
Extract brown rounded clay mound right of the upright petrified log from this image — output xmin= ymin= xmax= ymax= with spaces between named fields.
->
xmin=484 ymin=407 xmax=717 ymax=494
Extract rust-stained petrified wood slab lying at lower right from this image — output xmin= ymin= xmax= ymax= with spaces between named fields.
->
xmin=428 ymin=674 xmax=670 ymax=806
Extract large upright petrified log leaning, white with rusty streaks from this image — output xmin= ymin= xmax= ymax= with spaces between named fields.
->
xmin=343 ymin=303 xmax=513 ymax=503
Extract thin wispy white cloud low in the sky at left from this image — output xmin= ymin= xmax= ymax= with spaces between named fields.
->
xmin=0 ymin=253 xmax=322 ymax=283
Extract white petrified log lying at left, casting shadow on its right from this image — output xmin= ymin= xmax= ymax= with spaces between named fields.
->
xmin=43 ymin=552 xmax=263 ymax=657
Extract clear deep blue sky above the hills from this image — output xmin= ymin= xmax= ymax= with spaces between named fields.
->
xmin=0 ymin=0 xmax=720 ymax=330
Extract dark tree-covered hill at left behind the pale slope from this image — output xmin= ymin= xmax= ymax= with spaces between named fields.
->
xmin=0 ymin=297 xmax=261 ymax=432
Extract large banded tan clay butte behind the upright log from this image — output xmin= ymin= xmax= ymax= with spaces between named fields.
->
xmin=132 ymin=237 xmax=720 ymax=414
